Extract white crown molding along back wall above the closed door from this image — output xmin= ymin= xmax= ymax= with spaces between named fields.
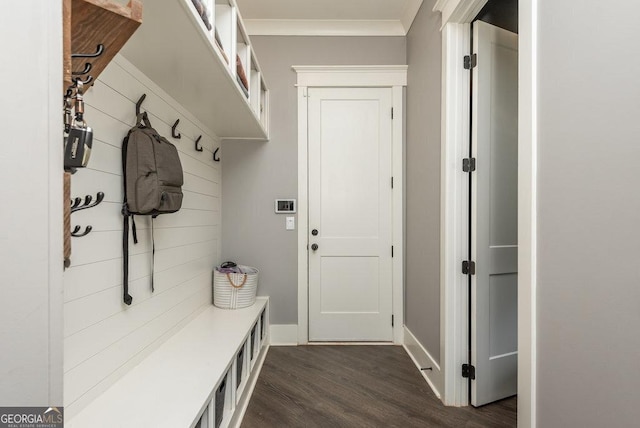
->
xmin=244 ymin=19 xmax=406 ymax=36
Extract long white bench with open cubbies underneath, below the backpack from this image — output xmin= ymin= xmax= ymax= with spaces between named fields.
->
xmin=65 ymin=297 xmax=269 ymax=428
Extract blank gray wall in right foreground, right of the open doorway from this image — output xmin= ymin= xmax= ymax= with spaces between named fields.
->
xmin=537 ymin=0 xmax=640 ymax=428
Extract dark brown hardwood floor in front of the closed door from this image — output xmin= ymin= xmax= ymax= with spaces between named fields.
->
xmin=242 ymin=346 xmax=517 ymax=428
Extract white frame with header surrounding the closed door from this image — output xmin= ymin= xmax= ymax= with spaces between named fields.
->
xmin=292 ymin=65 xmax=407 ymax=345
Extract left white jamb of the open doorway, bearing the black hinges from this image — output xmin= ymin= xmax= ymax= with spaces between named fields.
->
xmin=440 ymin=23 xmax=471 ymax=406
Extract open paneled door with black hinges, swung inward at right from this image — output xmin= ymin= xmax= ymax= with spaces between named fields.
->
xmin=471 ymin=21 xmax=518 ymax=406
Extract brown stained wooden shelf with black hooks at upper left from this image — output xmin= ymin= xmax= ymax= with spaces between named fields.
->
xmin=63 ymin=0 xmax=142 ymax=88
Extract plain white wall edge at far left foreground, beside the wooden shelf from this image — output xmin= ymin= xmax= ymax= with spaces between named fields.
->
xmin=0 ymin=1 xmax=62 ymax=406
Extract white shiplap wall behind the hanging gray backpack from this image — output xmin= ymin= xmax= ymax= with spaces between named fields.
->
xmin=64 ymin=56 xmax=221 ymax=417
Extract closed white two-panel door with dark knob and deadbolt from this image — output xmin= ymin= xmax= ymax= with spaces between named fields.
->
xmin=308 ymin=88 xmax=393 ymax=341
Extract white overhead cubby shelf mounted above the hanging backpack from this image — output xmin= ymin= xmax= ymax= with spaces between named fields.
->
xmin=122 ymin=0 xmax=268 ymax=140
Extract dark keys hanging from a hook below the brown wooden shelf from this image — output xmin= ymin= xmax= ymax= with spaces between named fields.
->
xmin=64 ymin=81 xmax=93 ymax=171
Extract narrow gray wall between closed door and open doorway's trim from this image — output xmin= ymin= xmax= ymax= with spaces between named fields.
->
xmin=405 ymin=0 xmax=442 ymax=362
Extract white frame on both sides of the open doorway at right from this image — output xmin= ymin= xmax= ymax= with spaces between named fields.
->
xmin=433 ymin=0 xmax=538 ymax=428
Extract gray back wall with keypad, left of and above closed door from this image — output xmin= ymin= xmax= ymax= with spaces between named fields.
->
xmin=222 ymin=36 xmax=406 ymax=324
